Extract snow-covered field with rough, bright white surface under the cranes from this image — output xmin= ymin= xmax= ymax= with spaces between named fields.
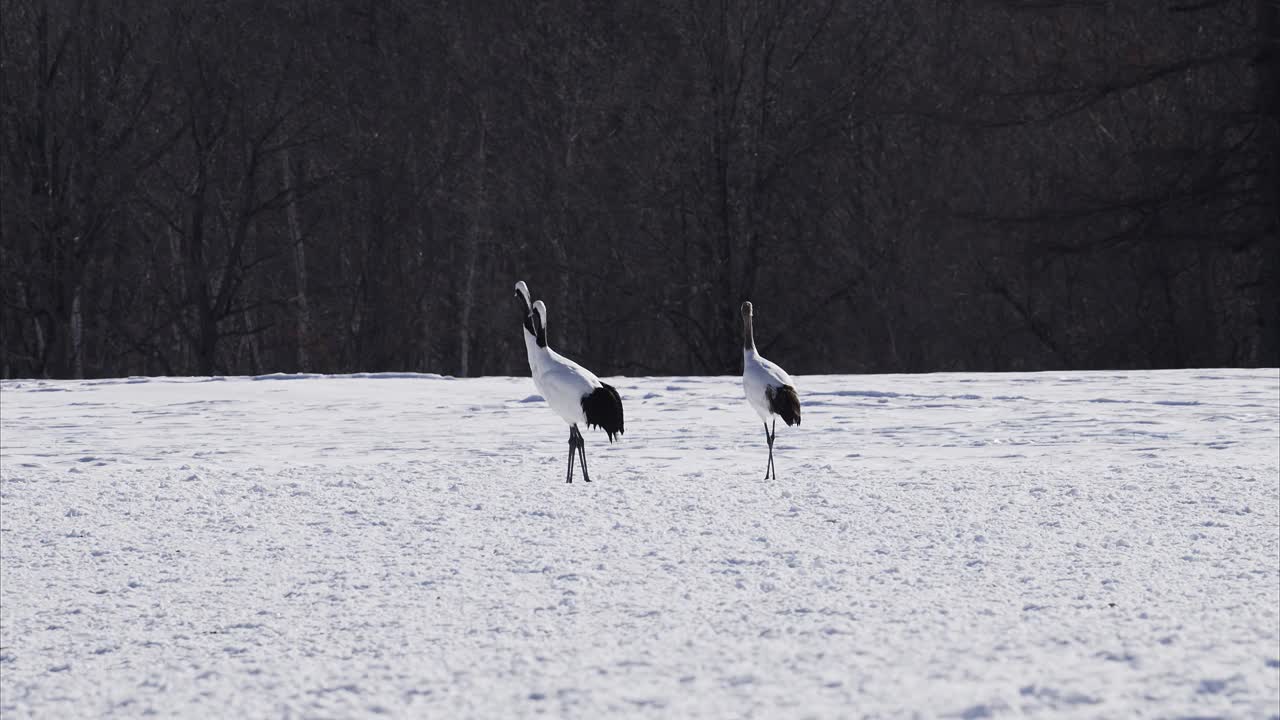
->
xmin=0 ymin=369 xmax=1280 ymax=720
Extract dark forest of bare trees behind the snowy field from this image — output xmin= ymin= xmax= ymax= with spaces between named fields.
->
xmin=0 ymin=0 xmax=1280 ymax=378
